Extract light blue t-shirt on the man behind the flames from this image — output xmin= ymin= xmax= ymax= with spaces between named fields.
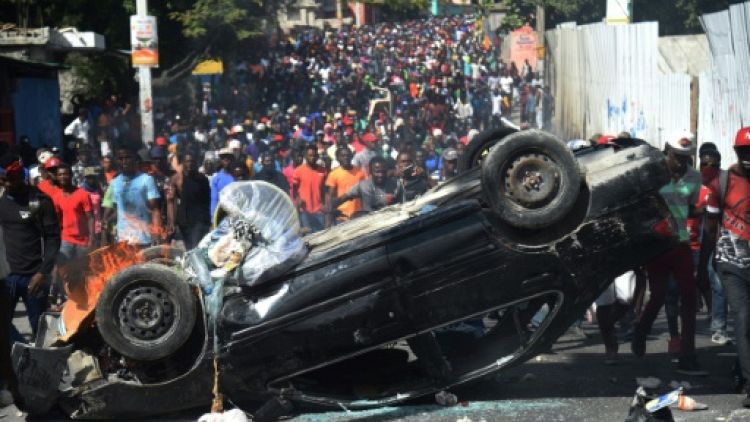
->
xmin=110 ymin=173 xmax=159 ymax=245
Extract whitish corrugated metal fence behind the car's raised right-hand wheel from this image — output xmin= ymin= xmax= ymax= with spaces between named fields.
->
xmin=546 ymin=22 xmax=691 ymax=147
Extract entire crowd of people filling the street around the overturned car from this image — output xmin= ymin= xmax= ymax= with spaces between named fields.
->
xmin=0 ymin=12 xmax=750 ymax=412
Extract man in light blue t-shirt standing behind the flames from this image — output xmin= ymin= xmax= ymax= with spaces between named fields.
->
xmin=110 ymin=148 xmax=165 ymax=246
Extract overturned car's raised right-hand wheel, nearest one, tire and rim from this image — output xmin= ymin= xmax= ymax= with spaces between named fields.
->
xmin=482 ymin=130 xmax=581 ymax=229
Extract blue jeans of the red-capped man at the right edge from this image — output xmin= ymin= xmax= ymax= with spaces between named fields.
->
xmin=717 ymin=263 xmax=750 ymax=392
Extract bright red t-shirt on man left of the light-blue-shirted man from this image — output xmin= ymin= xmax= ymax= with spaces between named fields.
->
xmin=52 ymin=188 xmax=92 ymax=245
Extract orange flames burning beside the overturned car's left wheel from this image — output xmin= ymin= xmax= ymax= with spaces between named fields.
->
xmin=62 ymin=243 xmax=143 ymax=341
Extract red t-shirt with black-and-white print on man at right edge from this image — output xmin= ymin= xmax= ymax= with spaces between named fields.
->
xmin=706 ymin=166 xmax=750 ymax=270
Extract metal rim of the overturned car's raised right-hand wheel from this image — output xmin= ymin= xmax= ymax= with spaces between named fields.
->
xmin=501 ymin=153 xmax=560 ymax=209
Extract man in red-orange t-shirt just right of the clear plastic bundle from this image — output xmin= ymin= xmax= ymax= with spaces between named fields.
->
xmin=292 ymin=144 xmax=326 ymax=233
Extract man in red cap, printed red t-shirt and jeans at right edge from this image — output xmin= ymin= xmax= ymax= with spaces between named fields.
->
xmin=698 ymin=126 xmax=750 ymax=407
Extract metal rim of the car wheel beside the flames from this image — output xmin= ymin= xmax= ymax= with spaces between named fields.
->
xmin=117 ymin=285 xmax=176 ymax=341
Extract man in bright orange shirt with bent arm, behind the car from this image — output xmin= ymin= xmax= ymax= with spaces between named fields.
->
xmin=326 ymin=147 xmax=367 ymax=227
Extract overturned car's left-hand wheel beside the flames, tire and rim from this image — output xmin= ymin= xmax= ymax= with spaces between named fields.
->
xmin=96 ymin=263 xmax=197 ymax=361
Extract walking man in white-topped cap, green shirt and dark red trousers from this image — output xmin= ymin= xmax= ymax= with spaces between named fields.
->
xmin=631 ymin=133 xmax=707 ymax=376
